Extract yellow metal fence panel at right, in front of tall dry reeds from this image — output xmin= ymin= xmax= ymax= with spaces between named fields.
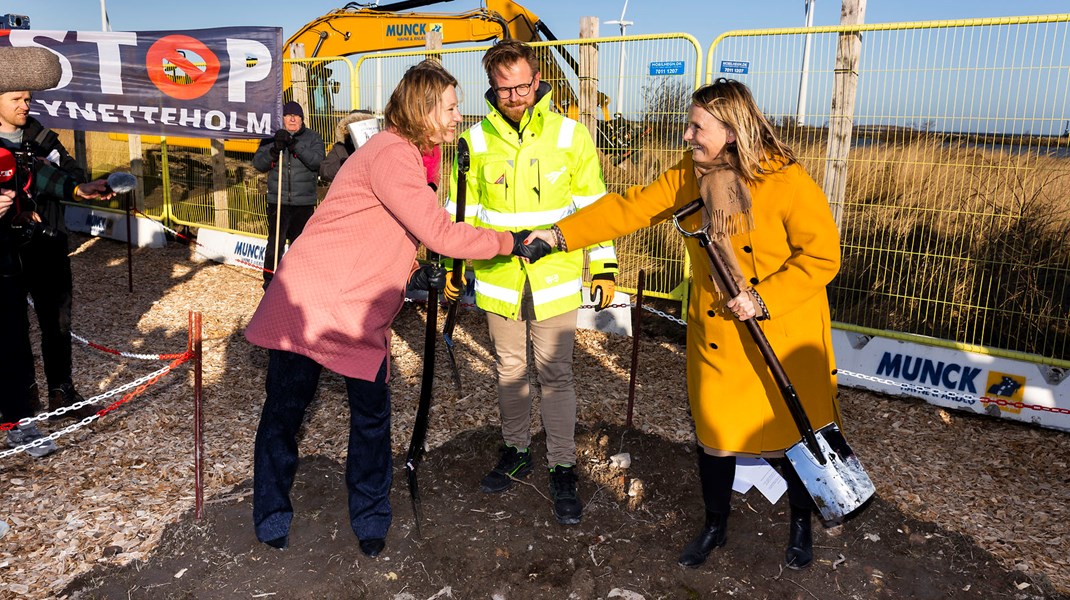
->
xmin=706 ymin=15 xmax=1070 ymax=366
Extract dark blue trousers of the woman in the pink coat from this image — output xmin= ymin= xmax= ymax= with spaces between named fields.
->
xmin=253 ymin=350 xmax=394 ymax=541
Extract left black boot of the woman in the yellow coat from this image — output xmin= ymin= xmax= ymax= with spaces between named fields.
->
xmin=678 ymin=447 xmax=735 ymax=567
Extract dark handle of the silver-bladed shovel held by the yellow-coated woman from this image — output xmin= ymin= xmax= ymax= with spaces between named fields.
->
xmin=673 ymin=198 xmax=825 ymax=465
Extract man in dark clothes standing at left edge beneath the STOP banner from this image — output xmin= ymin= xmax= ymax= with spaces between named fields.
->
xmin=0 ymin=92 xmax=92 ymax=418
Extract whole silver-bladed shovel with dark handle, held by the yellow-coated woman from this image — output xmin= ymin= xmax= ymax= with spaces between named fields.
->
xmin=673 ymin=198 xmax=876 ymax=524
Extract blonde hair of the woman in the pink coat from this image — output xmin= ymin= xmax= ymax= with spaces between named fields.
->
xmin=383 ymin=59 xmax=457 ymax=153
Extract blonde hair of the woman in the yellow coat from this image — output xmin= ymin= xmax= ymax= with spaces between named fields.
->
xmin=691 ymin=77 xmax=796 ymax=183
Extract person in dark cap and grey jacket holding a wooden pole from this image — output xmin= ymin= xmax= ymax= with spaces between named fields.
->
xmin=253 ymin=101 xmax=325 ymax=290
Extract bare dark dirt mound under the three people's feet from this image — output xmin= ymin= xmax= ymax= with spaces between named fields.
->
xmin=64 ymin=426 xmax=1059 ymax=600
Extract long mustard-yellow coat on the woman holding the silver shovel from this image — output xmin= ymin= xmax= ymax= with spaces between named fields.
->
xmin=557 ymin=155 xmax=840 ymax=455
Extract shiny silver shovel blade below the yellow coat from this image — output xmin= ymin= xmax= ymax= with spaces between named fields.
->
xmin=786 ymin=422 xmax=875 ymax=525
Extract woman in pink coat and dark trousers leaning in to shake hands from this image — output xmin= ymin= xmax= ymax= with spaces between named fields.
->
xmin=245 ymin=61 xmax=549 ymax=556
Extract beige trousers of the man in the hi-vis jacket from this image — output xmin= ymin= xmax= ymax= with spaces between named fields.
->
xmin=487 ymin=310 xmax=577 ymax=467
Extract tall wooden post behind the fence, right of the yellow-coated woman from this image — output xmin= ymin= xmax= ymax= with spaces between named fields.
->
xmin=825 ymin=0 xmax=866 ymax=227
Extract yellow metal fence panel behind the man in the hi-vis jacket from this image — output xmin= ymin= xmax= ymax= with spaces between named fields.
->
xmin=356 ymin=34 xmax=702 ymax=299
